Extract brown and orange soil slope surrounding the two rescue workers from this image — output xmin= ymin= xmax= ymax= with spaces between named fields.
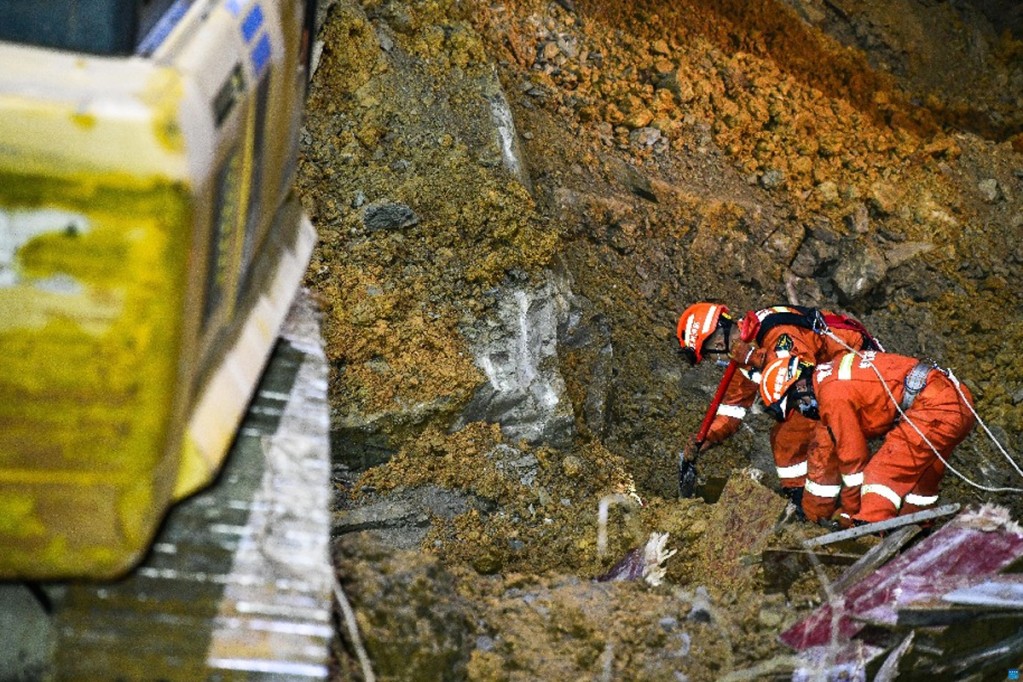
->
xmin=299 ymin=0 xmax=1023 ymax=680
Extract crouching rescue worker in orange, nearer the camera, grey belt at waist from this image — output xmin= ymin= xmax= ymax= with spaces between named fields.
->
xmin=760 ymin=352 xmax=976 ymax=527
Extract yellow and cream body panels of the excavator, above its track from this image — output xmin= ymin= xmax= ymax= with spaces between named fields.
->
xmin=0 ymin=1 xmax=315 ymax=580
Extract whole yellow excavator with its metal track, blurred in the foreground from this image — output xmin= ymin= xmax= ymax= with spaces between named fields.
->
xmin=0 ymin=0 xmax=329 ymax=680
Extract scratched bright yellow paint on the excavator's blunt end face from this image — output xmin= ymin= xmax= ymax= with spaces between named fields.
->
xmin=0 ymin=169 xmax=192 ymax=577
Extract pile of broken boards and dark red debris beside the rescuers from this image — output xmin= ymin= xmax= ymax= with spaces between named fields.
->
xmin=781 ymin=505 xmax=1023 ymax=680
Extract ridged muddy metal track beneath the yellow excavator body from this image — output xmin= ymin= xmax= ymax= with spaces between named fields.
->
xmin=0 ymin=292 xmax=333 ymax=682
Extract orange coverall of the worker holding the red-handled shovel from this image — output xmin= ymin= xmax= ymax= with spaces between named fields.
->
xmin=706 ymin=306 xmax=868 ymax=488
